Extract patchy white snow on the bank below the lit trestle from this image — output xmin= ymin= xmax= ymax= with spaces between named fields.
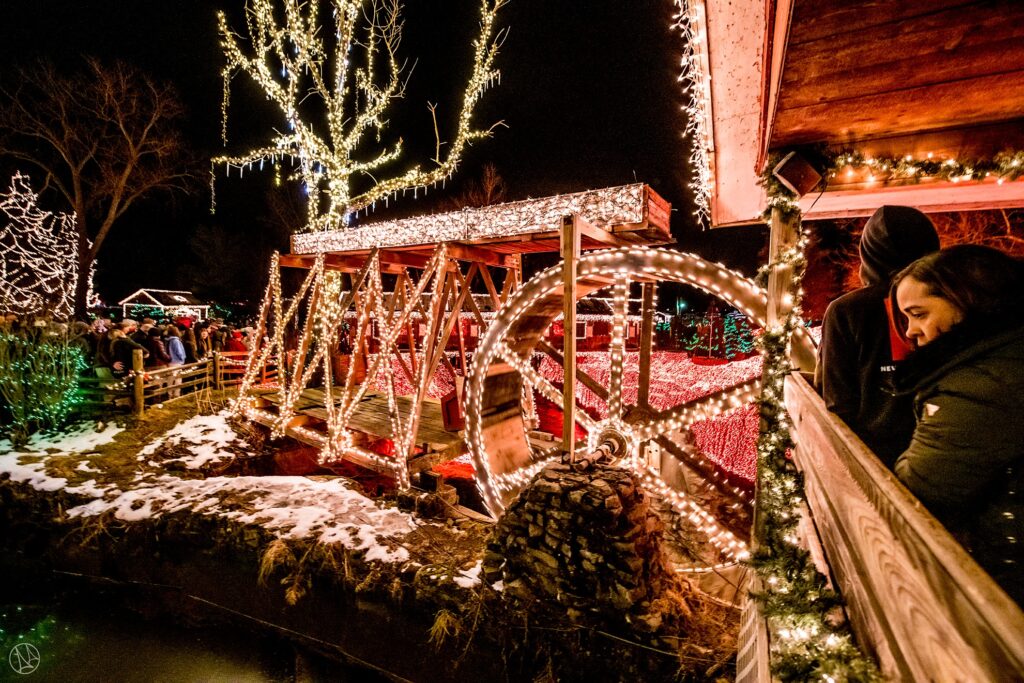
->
xmin=0 ymin=413 xmax=417 ymax=562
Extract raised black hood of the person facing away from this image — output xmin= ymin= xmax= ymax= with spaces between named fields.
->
xmin=860 ymin=206 xmax=939 ymax=287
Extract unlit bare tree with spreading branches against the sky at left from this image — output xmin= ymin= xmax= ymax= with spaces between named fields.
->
xmin=0 ymin=59 xmax=193 ymax=316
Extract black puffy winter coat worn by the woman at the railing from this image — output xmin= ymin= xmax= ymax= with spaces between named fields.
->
xmin=896 ymin=319 xmax=1024 ymax=604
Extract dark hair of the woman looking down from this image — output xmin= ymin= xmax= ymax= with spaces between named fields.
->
xmin=890 ymin=245 xmax=1024 ymax=319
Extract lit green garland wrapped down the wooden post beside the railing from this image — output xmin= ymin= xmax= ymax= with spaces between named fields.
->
xmin=751 ymin=158 xmax=882 ymax=683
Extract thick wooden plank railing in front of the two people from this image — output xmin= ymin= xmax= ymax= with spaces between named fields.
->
xmin=785 ymin=375 xmax=1024 ymax=681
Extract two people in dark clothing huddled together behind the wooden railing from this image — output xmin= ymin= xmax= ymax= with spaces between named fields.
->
xmin=816 ymin=206 xmax=1024 ymax=604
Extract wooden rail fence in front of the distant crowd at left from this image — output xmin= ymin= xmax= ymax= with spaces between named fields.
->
xmin=78 ymin=350 xmax=278 ymax=415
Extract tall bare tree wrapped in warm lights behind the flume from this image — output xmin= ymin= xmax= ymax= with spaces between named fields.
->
xmin=213 ymin=0 xmax=505 ymax=230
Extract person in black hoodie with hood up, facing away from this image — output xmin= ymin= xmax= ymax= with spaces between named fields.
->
xmin=815 ymin=206 xmax=939 ymax=468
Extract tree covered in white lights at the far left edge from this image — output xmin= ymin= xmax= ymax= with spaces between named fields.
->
xmin=0 ymin=173 xmax=79 ymax=318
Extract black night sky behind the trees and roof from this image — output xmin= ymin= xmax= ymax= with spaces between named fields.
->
xmin=0 ymin=0 xmax=764 ymax=309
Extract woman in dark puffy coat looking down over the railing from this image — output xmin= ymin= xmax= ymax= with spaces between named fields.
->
xmin=893 ymin=245 xmax=1024 ymax=605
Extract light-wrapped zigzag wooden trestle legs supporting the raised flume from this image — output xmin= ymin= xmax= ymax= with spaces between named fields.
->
xmin=234 ymin=244 xmax=458 ymax=488
